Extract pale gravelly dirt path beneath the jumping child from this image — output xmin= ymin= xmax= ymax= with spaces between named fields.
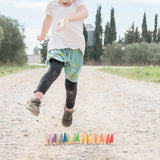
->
xmin=0 ymin=67 xmax=160 ymax=160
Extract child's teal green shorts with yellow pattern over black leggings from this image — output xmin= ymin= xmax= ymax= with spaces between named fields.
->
xmin=46 ymin=48 xmax=83 ymax=82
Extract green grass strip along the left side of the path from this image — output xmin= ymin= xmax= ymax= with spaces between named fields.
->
xmin=0 ymin=65 xmax=46 ymax=77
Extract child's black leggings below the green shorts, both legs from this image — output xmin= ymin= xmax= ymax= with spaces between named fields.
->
xmin=35 ymin=59 xmax=77 ymax=109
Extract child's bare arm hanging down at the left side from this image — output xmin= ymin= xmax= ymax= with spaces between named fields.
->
xmin=37 ymin=14 xmax=53 ymax=41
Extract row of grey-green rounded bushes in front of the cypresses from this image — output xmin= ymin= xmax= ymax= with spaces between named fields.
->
xmin=101 ymin=42 xmax=160 ymax=65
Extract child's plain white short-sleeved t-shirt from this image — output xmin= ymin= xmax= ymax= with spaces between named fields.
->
xmin=46 ymin=0 xmax=85 ymax=54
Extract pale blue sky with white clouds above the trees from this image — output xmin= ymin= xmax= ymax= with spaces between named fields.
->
xmin=0 ymin=0 xmax=160 ymax=54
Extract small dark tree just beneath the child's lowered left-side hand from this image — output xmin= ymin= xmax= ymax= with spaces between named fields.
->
xmin=40 ymin=38 xmax=49 ymax=63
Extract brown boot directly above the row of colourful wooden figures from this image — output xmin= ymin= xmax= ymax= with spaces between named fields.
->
xmin=62 ymin=107 xmax=73 ymax=127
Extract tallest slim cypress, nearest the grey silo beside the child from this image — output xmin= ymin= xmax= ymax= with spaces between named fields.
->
xmin=92 ymin=5 xmax=103 ymax=62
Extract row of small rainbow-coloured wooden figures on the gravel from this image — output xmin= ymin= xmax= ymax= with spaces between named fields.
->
xmin=45 ymin=133 xmax=114 ymax=145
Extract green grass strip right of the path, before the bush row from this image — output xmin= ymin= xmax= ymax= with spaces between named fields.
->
xmin=101 ymin=67 xmax=160 ymax=83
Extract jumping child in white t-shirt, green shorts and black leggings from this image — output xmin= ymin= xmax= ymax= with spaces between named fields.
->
xmin=27 ymin=0 xmax=88 ymax=127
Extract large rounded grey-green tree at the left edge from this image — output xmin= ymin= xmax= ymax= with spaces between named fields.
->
xmin=0 ymin=15 xmax=27 ymax=65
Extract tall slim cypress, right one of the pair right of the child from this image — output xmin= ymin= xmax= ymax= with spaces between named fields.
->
xmin=109 ymin=8 xmax=117 ymax=44
